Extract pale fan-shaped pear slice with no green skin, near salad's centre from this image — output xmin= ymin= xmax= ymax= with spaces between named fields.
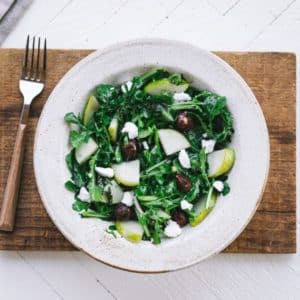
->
xmin=158 ymin=129 xmax=191 ymax=155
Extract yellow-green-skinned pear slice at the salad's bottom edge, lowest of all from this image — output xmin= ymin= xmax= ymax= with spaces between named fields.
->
xmin=116 ymin=221 xmax=144 ymax=243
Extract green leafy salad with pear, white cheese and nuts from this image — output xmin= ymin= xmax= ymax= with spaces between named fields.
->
xmin=65 ymin=68 xmax=235 ymax=244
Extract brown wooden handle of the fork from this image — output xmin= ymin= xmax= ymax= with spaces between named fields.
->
xmin=0 ymin=108 xmax=28 ymax=231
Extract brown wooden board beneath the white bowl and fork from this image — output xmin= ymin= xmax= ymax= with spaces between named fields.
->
xmin=0 ymin=49 xmax=296 ymax=253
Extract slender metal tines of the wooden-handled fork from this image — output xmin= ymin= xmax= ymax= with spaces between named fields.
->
xmin=21 ymin=35 xmax=47 ymax=82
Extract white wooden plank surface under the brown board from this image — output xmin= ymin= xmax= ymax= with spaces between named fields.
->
xmin=0 ymin=0 xmax=300 ymax=300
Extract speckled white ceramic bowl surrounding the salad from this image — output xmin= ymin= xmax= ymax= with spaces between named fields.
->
xmin=34 ymin=39 xmax=269 ymax=272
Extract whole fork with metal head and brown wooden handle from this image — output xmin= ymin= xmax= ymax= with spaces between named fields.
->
xmin=0 ymin=35 xmax=47 ymax=231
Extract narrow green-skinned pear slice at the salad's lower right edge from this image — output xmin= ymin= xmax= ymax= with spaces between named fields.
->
xmin=190 ymin=192 xmax=217 ymax=227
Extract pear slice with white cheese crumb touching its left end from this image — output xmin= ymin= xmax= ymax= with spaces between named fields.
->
xmin=112 ymin=160 xmax=140 ymax=186
